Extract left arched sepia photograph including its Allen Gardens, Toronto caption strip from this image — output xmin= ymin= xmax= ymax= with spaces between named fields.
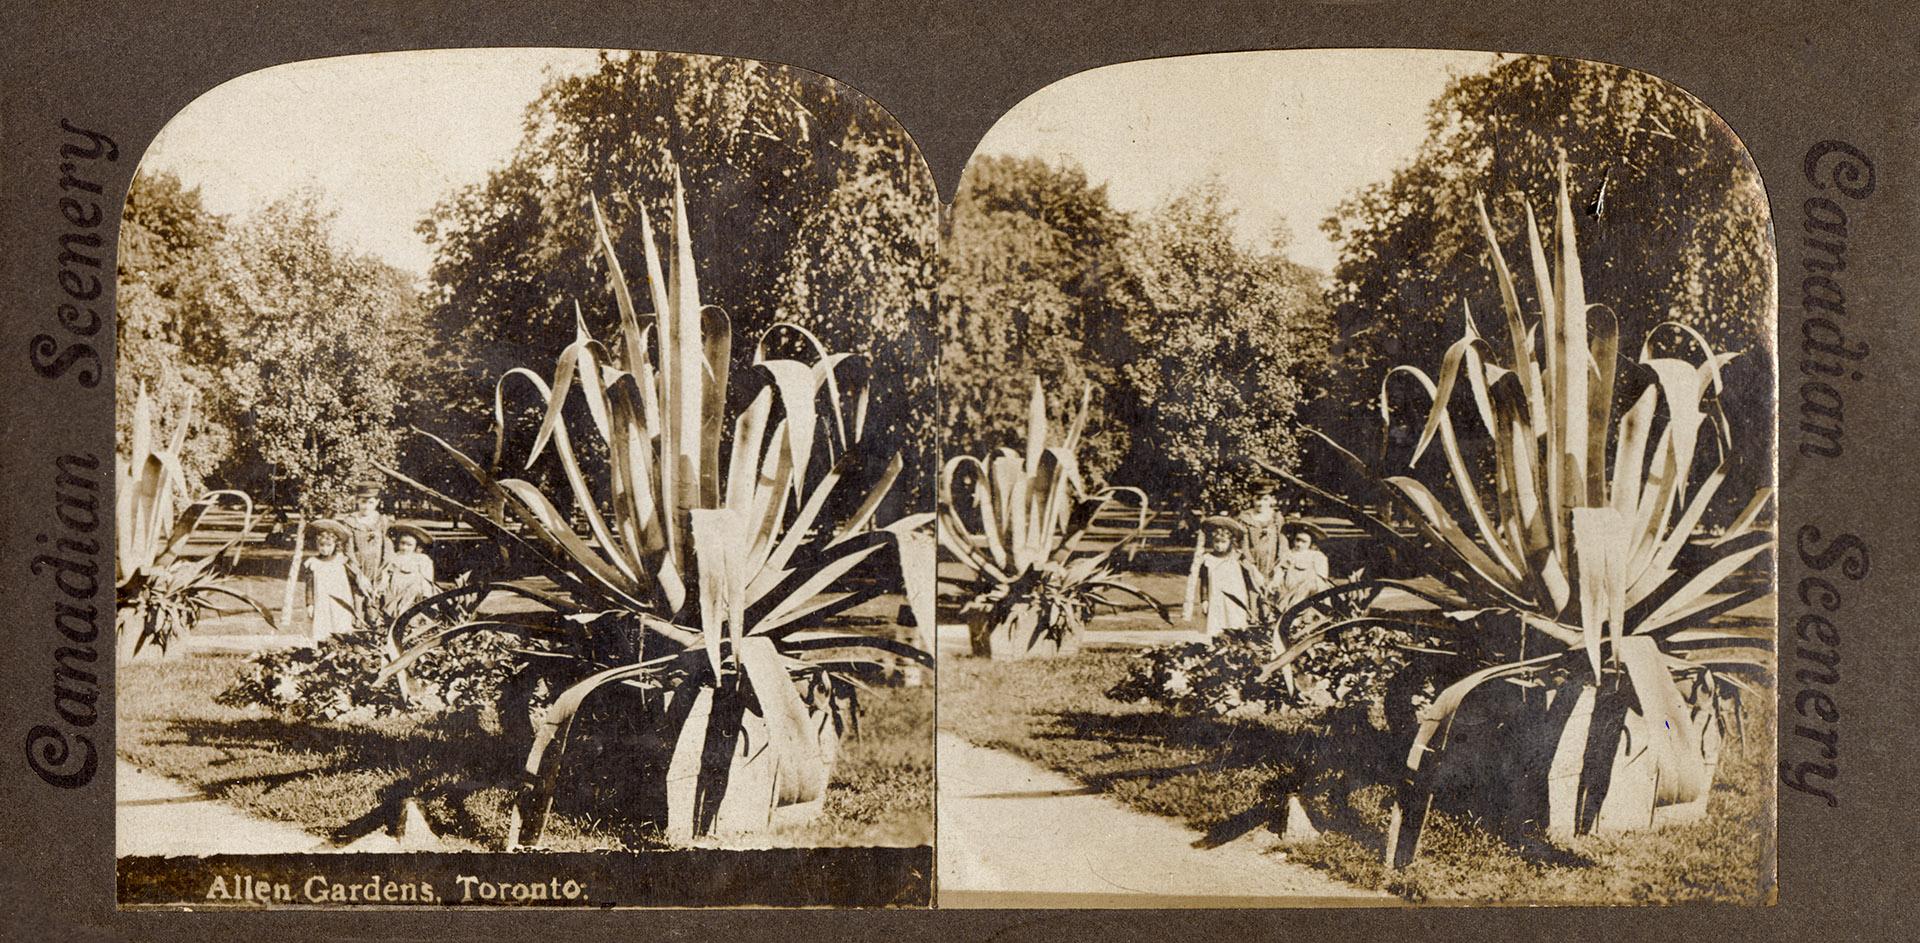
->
xmin=115 ymin=50 xmax=939 ymax=908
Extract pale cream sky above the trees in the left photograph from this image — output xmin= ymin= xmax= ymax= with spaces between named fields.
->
xmin=142 ymin=48 xmax=595 ymax=277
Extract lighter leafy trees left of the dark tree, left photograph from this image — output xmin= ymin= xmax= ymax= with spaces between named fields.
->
xmin=115 ymin=173 xmax=438 ymax=513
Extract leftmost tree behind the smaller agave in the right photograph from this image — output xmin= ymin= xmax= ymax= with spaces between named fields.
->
xmin=939 ymin=156 xmax=1129 ymax=476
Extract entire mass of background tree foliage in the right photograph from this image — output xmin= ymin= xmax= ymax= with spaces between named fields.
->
xmin=941 ymin=58 xmax=1772 ymax=511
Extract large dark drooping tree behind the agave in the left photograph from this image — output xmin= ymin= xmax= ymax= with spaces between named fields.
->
xmin=420 ymin=52 xmax=939 ymax=487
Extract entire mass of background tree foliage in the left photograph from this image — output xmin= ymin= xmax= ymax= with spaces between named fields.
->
xmin=119 ymin=52 xmax=939 ymax=513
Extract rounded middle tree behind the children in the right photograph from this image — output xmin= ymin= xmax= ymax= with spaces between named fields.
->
xmin=1117 ymin=181 xmax=1332 ymax=511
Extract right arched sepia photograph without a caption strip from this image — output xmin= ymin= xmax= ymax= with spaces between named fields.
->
xmin=937 ymin=50 xmax=1778 ymax=907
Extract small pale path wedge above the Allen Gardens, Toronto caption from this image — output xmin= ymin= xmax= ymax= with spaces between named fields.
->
xmin=113 ymin=761 xmax=330 ymax=855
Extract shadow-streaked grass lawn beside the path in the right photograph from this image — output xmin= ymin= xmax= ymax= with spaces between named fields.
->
xmin=939 ymin=651 xmax=1772 ymax=903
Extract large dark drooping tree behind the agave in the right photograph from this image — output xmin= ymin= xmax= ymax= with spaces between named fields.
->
xmin=1319 ymin=56 xmax=1772 ymax=492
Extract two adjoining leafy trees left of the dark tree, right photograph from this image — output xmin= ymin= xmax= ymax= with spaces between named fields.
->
xmin=941 ymin=157 xmax=1332 ymax=507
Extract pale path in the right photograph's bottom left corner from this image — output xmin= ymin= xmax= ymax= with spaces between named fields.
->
xmin=937 ymin=734 xmax=1396 ymax=907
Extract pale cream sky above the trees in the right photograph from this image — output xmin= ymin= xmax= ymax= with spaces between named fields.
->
xmin=977 ymin=50 xmax=1494 ymax=269
